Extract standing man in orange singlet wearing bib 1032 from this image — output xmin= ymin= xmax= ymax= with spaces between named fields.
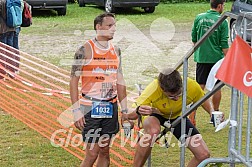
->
xmin=70 ymin=13 xmax=127 ymax=167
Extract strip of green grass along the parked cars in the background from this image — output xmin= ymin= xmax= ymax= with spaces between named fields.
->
xmin=22 ymin=3 xmax=231 ymax=34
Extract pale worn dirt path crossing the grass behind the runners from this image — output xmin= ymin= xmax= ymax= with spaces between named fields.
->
xmin=20 ymin=23 xmax=193 ymax=86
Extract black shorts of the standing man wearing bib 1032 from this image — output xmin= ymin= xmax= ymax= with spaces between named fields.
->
xmin=81 ymin=103 xmax=119 ymax=143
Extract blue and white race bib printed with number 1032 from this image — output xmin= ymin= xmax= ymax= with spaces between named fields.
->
xmin=91 ymin=102 xmax=113 ymax=118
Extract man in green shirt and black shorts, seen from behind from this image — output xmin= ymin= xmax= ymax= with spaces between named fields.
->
xmin=191 ymin=0 xmax=229 ymax=117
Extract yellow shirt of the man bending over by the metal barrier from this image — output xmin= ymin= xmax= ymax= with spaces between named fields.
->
xmin=133 ymin=78 xmax=204 ymax=119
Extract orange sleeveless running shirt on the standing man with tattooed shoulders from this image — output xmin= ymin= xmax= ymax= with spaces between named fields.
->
xmin=81 ymin=40 xmax=119 ymax=100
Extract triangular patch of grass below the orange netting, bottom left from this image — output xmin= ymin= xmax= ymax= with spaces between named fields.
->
xmin=0 ymin=111 xmax=80 ymax=167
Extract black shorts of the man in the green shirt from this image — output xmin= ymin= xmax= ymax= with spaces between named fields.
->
xmin=196 ymin=63 xmax=215 ymax=85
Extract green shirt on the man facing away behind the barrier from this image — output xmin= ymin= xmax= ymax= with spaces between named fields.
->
xmin=192 ymin=10 xmax=229 ymax=63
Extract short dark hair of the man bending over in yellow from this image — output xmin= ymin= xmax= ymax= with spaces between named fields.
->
xmin=158 ymin=68 xmax=182 ymax=93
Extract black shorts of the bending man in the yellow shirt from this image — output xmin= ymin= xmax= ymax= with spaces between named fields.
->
xmin=150 ymin=114 xmax=200 ymax=140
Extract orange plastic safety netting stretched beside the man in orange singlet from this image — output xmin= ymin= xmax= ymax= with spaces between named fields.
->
xmin=0 ymin=43 xmax=140 ymax=167
